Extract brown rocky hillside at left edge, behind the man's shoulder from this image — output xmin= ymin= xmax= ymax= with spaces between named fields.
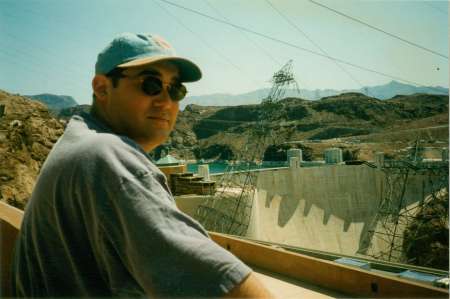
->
xmin=0 ymin=90 xmax=64 ymax=208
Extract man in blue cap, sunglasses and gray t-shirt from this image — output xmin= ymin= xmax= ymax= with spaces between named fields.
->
xmin=13 ymin=33 xmax=270 ymax=298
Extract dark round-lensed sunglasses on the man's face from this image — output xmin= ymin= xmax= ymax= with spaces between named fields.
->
xmin=121 ymin=74 xmax=187 ymax=102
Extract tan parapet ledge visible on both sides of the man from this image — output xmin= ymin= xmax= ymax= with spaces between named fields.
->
xmin=0 ymin=202 xmax=449 ymax=298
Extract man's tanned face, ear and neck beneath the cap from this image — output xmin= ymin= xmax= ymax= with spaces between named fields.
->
xmin=104 ymin=62 xmax=179 ymax=151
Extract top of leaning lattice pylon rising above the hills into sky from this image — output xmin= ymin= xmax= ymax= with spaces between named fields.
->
xmin=263 ymin=59 xmax=300 ymax=103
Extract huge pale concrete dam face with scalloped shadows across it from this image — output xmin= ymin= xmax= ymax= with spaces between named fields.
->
xmin=177 ymin=159 xmax=448 ymax=261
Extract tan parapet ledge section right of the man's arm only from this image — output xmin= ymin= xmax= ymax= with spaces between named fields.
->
xmin=210 ymin=233 xmax=449 ymax=298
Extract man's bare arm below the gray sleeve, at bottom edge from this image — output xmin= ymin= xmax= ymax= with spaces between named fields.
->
xmin=224 ymin=272 xmax=275 ymax=298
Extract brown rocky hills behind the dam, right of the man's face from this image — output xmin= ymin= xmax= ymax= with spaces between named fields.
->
xmin=164 ymin=93 xmax=448 ymax=159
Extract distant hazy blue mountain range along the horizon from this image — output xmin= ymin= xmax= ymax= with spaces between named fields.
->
xmin=181 ymin=81 xmax=448 ymax=109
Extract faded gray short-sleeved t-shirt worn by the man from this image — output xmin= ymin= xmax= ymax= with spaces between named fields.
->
xmin=13 ymin=114 xmax=251 ymax=298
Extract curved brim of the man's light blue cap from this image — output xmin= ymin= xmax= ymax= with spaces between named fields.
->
xmin=117 ymin=56 xmax=202 ymax=82
